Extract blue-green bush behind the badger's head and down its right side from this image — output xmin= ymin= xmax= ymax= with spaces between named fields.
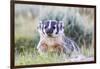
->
xmin=41 ymin=11 xmax=93 ymax=48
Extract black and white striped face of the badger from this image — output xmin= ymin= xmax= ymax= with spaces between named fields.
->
xmin=38 ymin=20 xmax=64 ymax=37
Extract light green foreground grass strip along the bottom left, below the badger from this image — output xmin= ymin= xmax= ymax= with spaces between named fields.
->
xmin=15 ymin=52 xmax=63 ymax=65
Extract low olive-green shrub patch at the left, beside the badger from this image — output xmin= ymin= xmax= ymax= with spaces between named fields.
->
xmin=15 ymin=34 xmax=39 ymax=53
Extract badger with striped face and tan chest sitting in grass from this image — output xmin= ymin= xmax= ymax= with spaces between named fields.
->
xmin=37 ymin=20 xmax=80 ymax=56
